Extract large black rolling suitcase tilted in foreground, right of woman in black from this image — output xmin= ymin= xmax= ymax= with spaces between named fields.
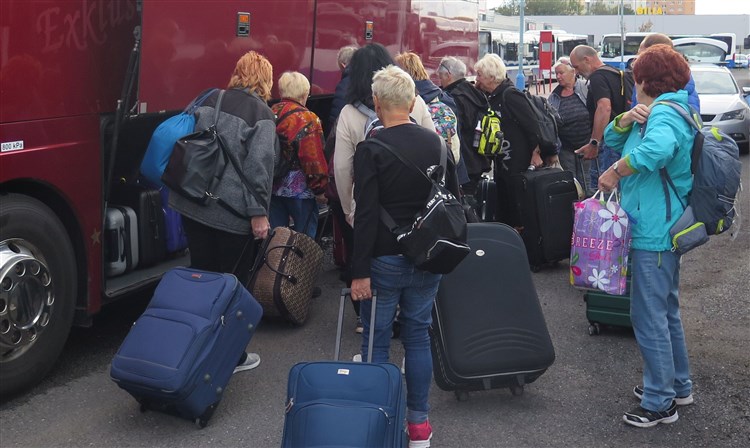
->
xmin=431 ymin=223 xmax=555 ymax=400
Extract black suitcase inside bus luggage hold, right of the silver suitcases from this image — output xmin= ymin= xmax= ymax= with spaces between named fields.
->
xmin=110 ymin=184 xmax=167 ymax=266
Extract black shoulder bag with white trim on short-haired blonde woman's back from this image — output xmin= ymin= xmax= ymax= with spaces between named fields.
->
xmin=370 ymin=137 xmax=470 ymax=274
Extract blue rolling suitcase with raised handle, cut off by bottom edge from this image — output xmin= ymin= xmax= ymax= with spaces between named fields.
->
xmin=281 ymin=289 xmax=406 ymax=448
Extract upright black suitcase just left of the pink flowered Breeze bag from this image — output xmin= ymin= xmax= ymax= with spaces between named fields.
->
xmin=510 ymin=168 xmax=578 ymax=272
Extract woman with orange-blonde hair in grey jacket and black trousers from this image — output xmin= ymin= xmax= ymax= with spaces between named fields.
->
xmin=169 ymin=51 xmax=279 ymax=373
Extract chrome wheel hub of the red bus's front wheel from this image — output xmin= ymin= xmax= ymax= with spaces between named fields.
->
xmin=0 ymin=239 xmax=55 ymax=361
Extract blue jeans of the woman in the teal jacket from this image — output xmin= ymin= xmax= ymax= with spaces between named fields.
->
xmin=630 ymin=249 xmax=693 ymax=411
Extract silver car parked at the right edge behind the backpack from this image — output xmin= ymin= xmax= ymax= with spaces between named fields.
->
xmin=690 ymin=65 xmax=750 ymax=153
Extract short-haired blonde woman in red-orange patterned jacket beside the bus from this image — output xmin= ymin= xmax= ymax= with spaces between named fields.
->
xmin=271 ymin=72 xmax=328 ymax=238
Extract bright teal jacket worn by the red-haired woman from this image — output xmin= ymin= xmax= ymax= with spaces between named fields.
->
xmin=604 ymin=90 xmax=695 ymax=252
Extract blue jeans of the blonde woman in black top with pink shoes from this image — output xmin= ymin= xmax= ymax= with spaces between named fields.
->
xmin=360 ymin=255 xmax=442 ymax=423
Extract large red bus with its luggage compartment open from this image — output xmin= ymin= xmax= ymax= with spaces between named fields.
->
xmin=0 ymin=0 xmax=478 ymax=394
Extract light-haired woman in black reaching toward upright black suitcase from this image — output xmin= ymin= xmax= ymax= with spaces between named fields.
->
xmin=474 ymin=53 xmax=558 ymax=229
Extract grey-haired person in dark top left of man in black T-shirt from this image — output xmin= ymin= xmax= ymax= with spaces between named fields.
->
xmin=548 ymin=57 xmax=591 ymax=190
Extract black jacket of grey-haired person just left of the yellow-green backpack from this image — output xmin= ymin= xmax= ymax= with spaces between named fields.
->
xmin=445 ymin=78 xmax=490 ymax=177
